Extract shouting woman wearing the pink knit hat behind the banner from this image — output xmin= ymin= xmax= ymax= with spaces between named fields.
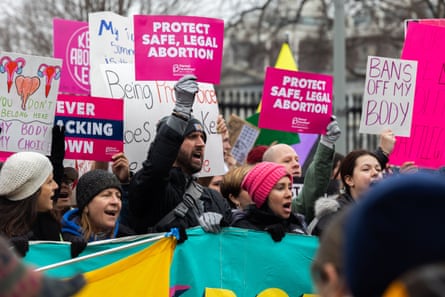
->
xmin=231 ymin=162 xmax=307 ymax=241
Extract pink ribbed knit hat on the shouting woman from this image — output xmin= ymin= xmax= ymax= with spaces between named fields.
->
xmin=241 ymin=162 xmax=292 ymax=208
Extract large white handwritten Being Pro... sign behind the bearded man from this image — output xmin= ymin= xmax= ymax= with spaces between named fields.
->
xmin=95 ymin=64 xmax=225 ymax=176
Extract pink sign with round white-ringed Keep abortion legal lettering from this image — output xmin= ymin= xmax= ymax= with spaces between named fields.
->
xmin=53 ymin=19 xmax=90 ymax=95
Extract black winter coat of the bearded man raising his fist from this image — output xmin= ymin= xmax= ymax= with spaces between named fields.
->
xmin=128 ymin=116 xmax=231 ymax=234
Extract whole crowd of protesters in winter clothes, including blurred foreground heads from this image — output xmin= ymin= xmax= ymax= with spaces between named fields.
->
xmin=0 ymin=75 xmax=445 ymax=296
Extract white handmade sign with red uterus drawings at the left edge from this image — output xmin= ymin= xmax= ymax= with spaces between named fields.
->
xmin=0 ymin=52 xmax=62 ymax=155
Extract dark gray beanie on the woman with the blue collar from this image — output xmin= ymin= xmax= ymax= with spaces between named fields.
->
xmin=76 ymin=169 xmax=122 ymax=213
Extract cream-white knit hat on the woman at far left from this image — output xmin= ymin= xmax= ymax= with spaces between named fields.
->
xmin=0 ymin=152 xmax=53 ymax=201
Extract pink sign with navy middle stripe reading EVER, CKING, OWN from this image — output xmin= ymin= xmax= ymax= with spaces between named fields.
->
xmin=55 ymin=95 xmax=124 ymax=161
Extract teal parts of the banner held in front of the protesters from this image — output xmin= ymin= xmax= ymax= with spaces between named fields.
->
xmin=25 ymin=227 xmax=318 ymax=297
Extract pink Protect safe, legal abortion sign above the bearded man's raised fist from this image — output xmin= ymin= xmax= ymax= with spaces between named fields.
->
xmin=134 ymin=15 xmax=224 ymax=84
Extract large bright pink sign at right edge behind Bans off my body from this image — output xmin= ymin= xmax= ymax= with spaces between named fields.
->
xmin=390 ymin=22 xmax=445 ymax=168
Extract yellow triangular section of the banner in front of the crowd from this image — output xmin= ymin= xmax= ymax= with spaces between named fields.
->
xmin=75 ymin=237 xmax=176 ymax=297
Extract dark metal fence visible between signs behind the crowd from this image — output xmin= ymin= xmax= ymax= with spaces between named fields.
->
xmin=216 ymin=86 xmax=378 ymax=152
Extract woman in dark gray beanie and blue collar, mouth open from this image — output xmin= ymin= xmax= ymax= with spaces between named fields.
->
xmin=62 ymin=169 xmax=134 ymax=254
